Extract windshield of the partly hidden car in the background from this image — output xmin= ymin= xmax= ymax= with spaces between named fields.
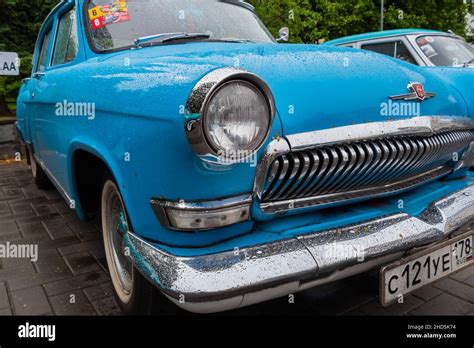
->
xmin=416 ymin=35 xmax=474 ymax=67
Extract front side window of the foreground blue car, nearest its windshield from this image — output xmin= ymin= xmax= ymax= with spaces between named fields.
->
xmin=53 ymin=9 xmax=78 ymax=65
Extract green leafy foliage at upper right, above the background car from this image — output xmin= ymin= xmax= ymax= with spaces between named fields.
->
xmin=249 ymin=0 xmax=467 ymax=43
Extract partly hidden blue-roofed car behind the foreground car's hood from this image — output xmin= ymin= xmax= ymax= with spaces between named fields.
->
xmin=324 ymin=29 xmax=474 ymax=68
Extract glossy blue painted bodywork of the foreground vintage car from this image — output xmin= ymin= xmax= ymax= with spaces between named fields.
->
xmin=18 ymin=0 xmax=474 ymax=253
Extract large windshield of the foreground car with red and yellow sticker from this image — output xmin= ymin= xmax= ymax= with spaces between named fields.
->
xmin=86 ymin=0 xmax=274 ymax=51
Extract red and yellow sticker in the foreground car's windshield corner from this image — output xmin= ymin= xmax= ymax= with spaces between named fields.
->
xmin=89 ymin=0 xmax=130 ymax=30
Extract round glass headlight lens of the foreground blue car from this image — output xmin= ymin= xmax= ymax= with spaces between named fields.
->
xmin=204 ymin=81 xmax=271 ymax=152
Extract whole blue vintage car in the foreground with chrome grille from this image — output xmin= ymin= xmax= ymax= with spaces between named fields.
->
xmin=17 ymin=0 xmax=474 ymax=313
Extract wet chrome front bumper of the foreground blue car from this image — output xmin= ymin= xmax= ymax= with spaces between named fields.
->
xmin=125 ymin=185 xmax=474 ymax=313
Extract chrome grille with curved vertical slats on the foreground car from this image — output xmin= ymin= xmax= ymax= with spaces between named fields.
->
xmin=262 ymin=130 xmax=474 ymax=205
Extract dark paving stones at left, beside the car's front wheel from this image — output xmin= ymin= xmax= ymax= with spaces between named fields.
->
xmin=0 ymin=163 xmax=121 ymax=315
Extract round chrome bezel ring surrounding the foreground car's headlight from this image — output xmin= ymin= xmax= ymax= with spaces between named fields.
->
xmin=185 ymin=68 xmax=276 ymax=164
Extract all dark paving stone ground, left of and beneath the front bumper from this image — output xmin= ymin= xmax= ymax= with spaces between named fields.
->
xmin=0 ymin=163 xmax=474 ymax=315
